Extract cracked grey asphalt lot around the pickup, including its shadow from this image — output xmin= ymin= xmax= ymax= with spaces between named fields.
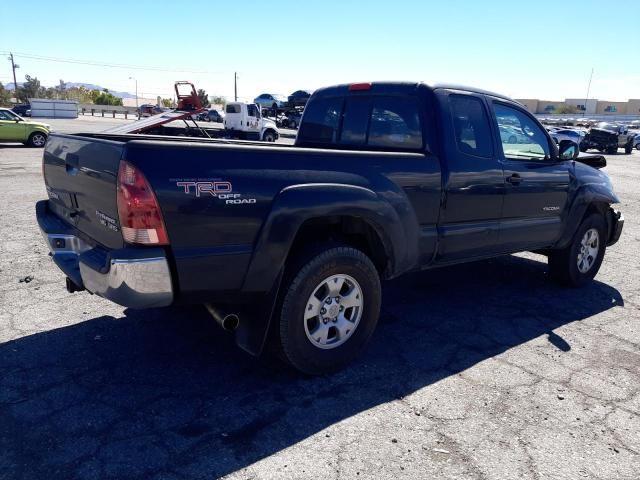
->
xmin=0 ymin=119 xmax=640 ymax=480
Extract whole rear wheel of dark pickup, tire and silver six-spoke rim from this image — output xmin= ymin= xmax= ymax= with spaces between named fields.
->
xmin=277 ymin=247 xmax=381 ymax=375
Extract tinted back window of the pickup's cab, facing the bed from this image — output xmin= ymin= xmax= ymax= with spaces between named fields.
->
xmin=298 ymin=95 xmax=424 ymax=151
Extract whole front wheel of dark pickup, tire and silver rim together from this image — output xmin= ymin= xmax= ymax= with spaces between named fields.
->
xmin=549 ymin=213 xmax=607 ymax=287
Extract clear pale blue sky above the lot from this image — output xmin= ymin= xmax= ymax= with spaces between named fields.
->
xmin=0 ymin=0 xmax=640 ymax=100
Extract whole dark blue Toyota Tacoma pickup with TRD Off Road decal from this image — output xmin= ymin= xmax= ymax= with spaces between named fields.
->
xmin=36 ymin=83 xmax=624 ymax=374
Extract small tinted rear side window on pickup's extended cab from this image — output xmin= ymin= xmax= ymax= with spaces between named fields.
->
xmin=449 ymin=95 xmax=493 ymax=158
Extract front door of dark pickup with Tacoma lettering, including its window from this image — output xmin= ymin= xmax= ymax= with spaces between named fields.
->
xmin=492 ymin=100 xmax=570 ymax=252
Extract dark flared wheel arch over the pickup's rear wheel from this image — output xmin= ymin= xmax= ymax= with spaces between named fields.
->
xmin=243 ymin=184 xmax=407 ymax=292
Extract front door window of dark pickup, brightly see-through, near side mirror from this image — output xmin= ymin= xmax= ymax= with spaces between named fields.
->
xmin=493 ymin=103 xmax=551 ymax=161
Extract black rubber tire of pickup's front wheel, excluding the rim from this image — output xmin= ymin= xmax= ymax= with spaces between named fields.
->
xmin=549 ymin=213 xmax=607 ymax=287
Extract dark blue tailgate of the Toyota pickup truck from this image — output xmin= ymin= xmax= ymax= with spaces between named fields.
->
xmin=43 ymin=134 xmax=125 ymax=248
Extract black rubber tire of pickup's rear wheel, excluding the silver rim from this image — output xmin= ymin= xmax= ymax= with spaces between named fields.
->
xmin=276 ymin=245 xmax=381 ymax=375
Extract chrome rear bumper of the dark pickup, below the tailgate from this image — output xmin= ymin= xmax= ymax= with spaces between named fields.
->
xmin=36 ymin=200 xmax=174 ymax=308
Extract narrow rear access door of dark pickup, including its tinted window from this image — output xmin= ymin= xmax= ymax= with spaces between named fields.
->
xmin=435 ymin=90 xmax=504 ymax=263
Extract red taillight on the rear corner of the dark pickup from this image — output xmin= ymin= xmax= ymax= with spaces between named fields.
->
xmin=118 ymin=160 xmax=169 ymax=245
